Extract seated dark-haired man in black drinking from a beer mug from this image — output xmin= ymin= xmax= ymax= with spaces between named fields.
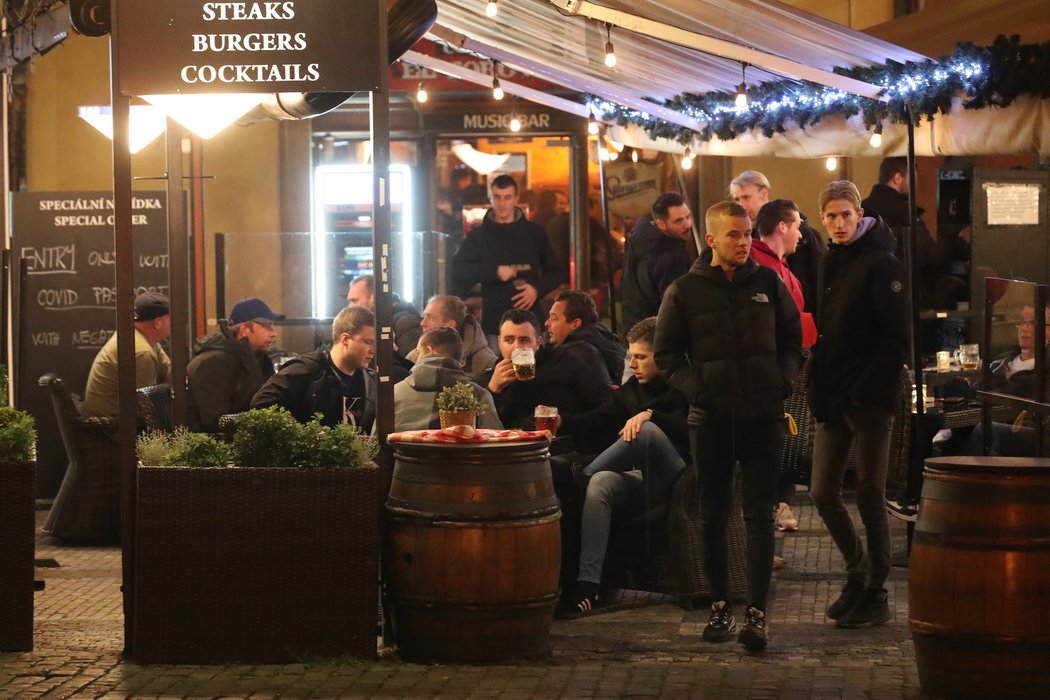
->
xmin=479 ymin=309 xmax=612 ymax=430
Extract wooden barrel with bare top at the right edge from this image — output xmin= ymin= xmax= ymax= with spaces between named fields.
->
xmin=908 ymin=457 xmax=1050 ymax=698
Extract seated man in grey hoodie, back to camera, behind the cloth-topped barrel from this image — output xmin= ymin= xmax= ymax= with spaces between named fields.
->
xmin=394 ymin=326 xmax=503 ymax=431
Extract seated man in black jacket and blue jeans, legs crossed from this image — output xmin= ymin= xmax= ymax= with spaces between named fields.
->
xmin=560 ymin=317 xmax=691 ymax=617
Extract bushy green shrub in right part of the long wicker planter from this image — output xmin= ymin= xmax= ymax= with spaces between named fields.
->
xmin=233 ymin=406 xmax=379 ymax=468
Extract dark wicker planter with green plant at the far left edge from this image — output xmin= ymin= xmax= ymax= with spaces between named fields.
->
xmin=0 ymin=402 xmax=37 ymax=652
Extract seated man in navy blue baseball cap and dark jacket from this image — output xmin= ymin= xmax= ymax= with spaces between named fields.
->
xmin=186 ymin=297 xmax=285 ymax=432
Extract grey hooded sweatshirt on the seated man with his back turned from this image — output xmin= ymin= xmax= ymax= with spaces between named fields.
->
xmin=394 ymin=355 xmax=503 ymax=431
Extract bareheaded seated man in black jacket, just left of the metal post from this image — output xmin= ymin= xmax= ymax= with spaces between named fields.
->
xmin=251 ymin=306 xmax=376 ymax=433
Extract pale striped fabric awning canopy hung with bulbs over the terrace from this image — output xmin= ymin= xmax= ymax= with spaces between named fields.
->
xmin=429 ymin=0 xmax=1050 ymax=157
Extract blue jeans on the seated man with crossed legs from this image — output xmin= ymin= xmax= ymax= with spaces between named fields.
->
xmin=576 ymin=422 xmax=686 ymax=584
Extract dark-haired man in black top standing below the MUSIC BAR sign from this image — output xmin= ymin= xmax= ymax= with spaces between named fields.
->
xmin=453 ymin=175 xmax=566 ymax=349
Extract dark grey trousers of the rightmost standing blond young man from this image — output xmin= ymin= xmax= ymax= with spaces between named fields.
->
xmin=810 ymin=406 xmax=894 ymax=588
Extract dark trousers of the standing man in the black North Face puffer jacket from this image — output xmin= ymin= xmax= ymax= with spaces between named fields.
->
xmin=690 ymin=416 xmax=784 ymax=611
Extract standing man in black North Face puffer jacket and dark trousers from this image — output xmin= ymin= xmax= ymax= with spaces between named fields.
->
xmin=656 ymin=201 xmax=802 ymax=651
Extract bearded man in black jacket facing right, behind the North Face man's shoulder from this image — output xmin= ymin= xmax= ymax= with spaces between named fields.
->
xmin=614 ymin=192 xmax=693 ymax=333
